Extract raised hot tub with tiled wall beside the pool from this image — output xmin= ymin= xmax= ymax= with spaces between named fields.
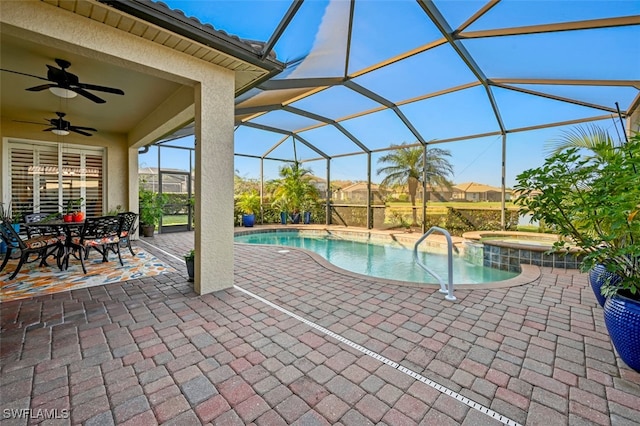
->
xmin=462 ymin=231 xmax=581 ymax=271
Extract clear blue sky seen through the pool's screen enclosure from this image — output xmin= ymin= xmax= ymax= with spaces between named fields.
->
xmin=140 ymin=0 xmax=640 ymax=187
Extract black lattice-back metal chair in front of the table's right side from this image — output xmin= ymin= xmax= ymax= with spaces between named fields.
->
xmin=63 ymin=216 xmax=124 ymax=274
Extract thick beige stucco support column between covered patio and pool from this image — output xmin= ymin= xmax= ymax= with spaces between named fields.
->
xmin=193 ymin=70 xmax=234 ymax=294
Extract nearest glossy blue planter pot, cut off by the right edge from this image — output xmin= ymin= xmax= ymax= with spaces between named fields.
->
xmin=604 ymin=296 xmax=640 ymax=372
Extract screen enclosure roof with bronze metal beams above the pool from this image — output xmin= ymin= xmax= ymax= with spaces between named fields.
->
xmin=161 ymin=0 xmax=640 ymax=166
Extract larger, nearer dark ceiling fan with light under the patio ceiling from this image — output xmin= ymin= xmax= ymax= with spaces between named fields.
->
xmin=0 ymin=59 xmax=124 ymax=104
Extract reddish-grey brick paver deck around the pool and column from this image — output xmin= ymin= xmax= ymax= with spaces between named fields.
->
xmin=0 ymin=228 xmax=640 ymax=426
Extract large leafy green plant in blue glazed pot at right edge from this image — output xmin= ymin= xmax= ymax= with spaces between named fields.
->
xmin=515 ymin=129 xmax=640 ymax=371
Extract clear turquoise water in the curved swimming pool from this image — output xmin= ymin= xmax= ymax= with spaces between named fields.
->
xmin=235 ymin=231 xmax=518 ymax=284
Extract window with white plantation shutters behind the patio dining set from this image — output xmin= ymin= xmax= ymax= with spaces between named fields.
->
xmin=8 ymin=141 xmax=104 ymax=220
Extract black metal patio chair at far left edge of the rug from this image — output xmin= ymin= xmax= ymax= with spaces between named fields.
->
xmin=0 ymin=222 xmax=63 ymax=280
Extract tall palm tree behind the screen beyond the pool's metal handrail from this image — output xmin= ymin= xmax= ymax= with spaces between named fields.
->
xmin=377 ymin=142 xmax=453 ymax=225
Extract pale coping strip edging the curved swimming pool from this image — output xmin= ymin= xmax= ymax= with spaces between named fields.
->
xmin=234 ymin=225 xmax=541 ymax=290
